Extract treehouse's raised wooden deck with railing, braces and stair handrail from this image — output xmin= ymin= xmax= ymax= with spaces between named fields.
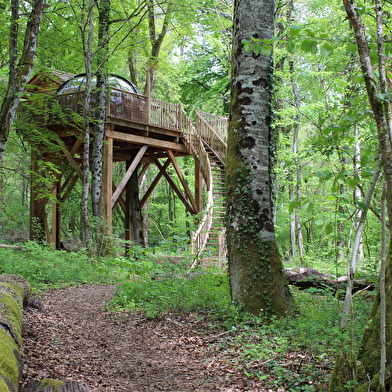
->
xmin=28 ymin=79 xmax=227 ymax=258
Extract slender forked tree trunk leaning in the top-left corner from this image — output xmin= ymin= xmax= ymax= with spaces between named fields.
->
xmin=0 ymin=0 xmax=45 ymax=164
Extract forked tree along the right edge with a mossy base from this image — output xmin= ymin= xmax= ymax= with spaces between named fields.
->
xmin=330 ymin=0 xmax=392 ymax=392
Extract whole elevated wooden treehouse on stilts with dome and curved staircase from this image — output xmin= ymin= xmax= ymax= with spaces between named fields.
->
xmin=23 ymin=71 xmax=227 ymax=258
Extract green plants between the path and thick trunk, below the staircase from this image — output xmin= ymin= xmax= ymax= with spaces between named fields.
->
xmin=108 ymin=254 xmax=236 ymax=321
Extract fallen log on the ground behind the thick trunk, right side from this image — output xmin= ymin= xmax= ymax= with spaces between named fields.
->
xmin=285 ymin=267 xmax=375 ymax=293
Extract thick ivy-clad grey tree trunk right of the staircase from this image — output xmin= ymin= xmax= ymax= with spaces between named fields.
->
xmin=226 ymin=0 xmax=293 ymax=316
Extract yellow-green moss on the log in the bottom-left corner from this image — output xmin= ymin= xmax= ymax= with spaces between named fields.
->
xmin=0 ymin=329 xmax=19 ymax=391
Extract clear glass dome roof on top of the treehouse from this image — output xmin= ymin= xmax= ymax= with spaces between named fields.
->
xmin=57 ymin=73 xmax=141 ymax=95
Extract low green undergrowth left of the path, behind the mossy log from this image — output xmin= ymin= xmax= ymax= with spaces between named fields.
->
xmin=0 ymin=242 xmax=116 ymax=293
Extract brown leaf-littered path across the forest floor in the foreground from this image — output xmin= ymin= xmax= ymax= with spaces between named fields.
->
xmin=22 ymin=285 xmax=332 ymax=392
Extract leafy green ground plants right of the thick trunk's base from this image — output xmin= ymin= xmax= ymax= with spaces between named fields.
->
xmin=224 ymin=292 xmax=371 ymax=392
